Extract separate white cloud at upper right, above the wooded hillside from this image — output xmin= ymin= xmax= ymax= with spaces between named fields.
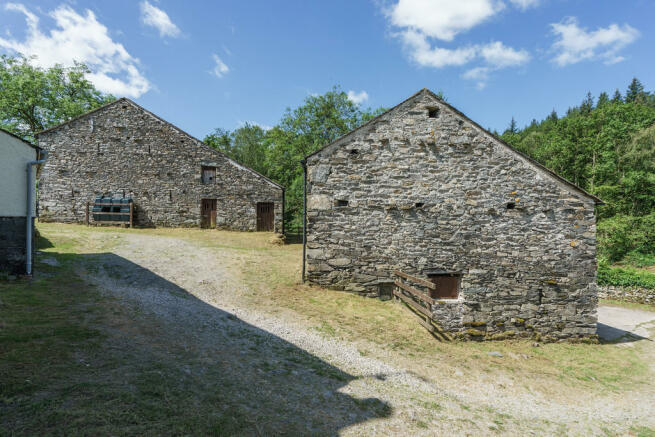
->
xmin=550 ymin=17 xmax=639 ymax=66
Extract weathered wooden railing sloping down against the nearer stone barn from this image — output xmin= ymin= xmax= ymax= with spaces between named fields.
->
xmin=393 ymin=270 xmax=451 ymax=340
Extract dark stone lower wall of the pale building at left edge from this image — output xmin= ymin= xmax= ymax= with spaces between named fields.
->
xmin=0 ymin=217 xmax=34 ymax=275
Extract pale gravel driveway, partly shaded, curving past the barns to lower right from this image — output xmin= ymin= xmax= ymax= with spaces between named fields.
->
xmin=68 ymin=233 xmax=655 ymax=435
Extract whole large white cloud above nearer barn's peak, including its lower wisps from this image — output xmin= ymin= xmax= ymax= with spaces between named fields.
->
xmin=384 ymin=0 xmax=539 ymax=88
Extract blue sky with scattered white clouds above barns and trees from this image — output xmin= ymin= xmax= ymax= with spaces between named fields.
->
xmin=0 ymin=0 xmax=655 ymax=138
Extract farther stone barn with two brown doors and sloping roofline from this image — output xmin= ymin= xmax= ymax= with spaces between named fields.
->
xmin=37 ymin=98 xmax=284 ymax=232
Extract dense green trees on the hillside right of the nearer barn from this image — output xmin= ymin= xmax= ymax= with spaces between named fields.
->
xmin=500 ymin=78 xmax=655 ymax=264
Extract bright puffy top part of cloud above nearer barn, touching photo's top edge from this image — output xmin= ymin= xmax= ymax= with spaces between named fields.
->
xmin=386 ymin=0 xmax=505 ymax=41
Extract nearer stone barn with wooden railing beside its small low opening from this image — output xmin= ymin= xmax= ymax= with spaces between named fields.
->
xmin=304 ymin=89 xmax=601 ymax=339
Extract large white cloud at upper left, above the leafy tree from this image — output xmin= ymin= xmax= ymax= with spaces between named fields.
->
xmin=0 ymin=3 xmax=151 ymax=97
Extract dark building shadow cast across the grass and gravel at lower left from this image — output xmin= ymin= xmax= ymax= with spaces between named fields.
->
xmin=0 ymin=246 xmax=392 ymax=435
